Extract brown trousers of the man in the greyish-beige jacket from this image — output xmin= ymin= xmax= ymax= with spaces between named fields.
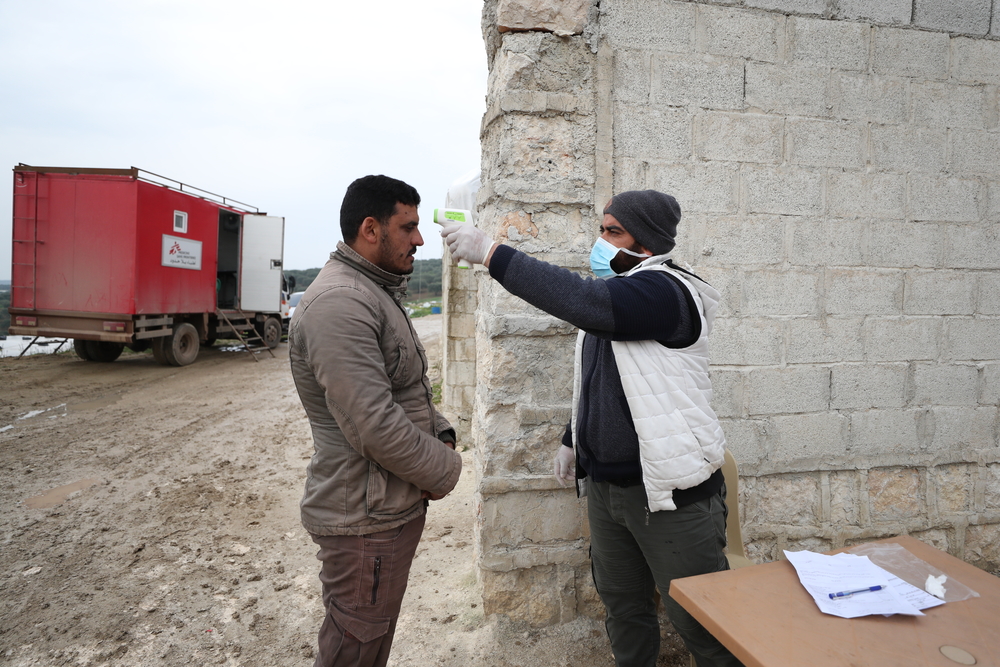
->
xmin=312 ymin=514 xmax=426 ymax=667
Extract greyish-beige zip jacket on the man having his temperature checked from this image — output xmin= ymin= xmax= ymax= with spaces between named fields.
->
xmin=288 ymin=243 xmax=462 ymax=535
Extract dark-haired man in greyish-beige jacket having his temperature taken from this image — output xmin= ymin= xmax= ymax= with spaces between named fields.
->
xmin=288 ymin=176 xmax=462 ymax=667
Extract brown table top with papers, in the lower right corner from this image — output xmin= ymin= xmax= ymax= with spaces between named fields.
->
xmin=670 ymin=536 xmax=1000 ymax=667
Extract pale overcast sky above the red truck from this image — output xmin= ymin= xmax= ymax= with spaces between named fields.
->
xmin=0 ymin=0 xmax=487 ymax=280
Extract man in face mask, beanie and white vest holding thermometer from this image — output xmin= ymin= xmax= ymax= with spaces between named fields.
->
xmin=441 ymin=190 xmax=740 ymax=667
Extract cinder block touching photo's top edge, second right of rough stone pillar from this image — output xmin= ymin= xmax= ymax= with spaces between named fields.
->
xmin=696 ymin=4 xmax=785 ymax=63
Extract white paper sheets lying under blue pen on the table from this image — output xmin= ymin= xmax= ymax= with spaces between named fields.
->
xmin=785 ymin=551 xmax=928 ymax=618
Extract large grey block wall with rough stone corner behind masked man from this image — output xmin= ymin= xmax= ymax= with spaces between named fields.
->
xmin=472 ymin=0 xmax=1000 ymax=625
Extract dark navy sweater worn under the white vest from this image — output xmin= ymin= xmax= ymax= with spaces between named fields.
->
xmin=490 ymin=245 xmax=722 ymax=507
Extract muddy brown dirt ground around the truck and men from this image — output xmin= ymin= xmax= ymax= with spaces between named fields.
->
xmin=0 ymin=316 xmax=686 ymax=667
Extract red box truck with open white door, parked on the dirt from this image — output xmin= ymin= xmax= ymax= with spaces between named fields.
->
xmin=9 ymin=164 xmax=294 ymax=366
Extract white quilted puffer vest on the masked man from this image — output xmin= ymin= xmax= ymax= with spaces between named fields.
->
xmin=573 ymin=255 xmax=726 ymax=512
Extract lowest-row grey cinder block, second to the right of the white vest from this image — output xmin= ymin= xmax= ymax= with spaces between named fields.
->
xmin=767 ymin=412 xmax=850 ymax=465
